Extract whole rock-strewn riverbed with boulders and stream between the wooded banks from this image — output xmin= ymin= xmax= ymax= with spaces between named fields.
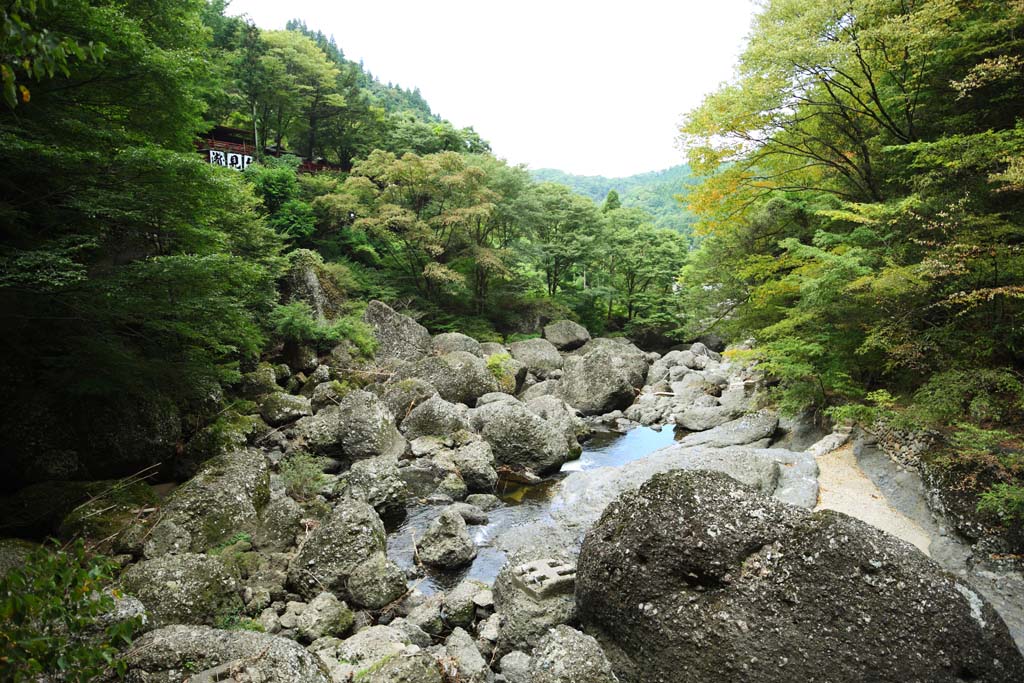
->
xmin=0 ymin=302 xmax=1024 ymax=683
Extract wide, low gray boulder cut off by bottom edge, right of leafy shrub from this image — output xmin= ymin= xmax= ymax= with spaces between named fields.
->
xmin=124 ymin=626 xmax=332 ymax=683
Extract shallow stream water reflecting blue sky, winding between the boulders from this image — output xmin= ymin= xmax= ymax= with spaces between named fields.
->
xmin=387 ymin=427 xmax=683 ymax=595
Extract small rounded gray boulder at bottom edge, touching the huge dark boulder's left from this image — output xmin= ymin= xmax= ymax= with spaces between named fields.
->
xmin=529 ymin=625 xmax=618 ymax=683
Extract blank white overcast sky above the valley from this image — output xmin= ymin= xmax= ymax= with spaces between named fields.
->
xmin=228 ymin=0 xmax=755 ymax=177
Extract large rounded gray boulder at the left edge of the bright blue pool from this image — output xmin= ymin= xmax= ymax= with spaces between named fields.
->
xmin=472 ymin=402 xmax=570 ymax=474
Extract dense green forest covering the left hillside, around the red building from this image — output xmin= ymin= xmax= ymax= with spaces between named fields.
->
xmin=0 ymin=0 xmax=686 ymax=485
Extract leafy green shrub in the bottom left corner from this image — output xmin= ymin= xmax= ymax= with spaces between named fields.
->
xmin=0 ymin=541 xmax=141 ymax=682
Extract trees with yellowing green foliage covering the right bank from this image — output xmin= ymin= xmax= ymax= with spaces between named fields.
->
xmin=681 ymin=0 xmax=1024 ymax=519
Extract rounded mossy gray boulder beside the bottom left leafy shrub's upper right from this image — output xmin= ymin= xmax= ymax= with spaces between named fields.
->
xmin=121 ymin=553 xmax=242 ymax=627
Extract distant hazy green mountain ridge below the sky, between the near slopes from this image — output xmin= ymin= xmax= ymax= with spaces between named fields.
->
xmin=529 ymin=164 xmax=697 ymax=234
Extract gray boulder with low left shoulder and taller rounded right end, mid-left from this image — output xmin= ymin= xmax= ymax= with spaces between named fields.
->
xmin=290 ymin=391 xmax=406 ymax=460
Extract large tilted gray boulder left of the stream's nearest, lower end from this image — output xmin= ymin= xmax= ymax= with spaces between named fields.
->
xmin=288 ymin=499 xmax=385 ymax=599
